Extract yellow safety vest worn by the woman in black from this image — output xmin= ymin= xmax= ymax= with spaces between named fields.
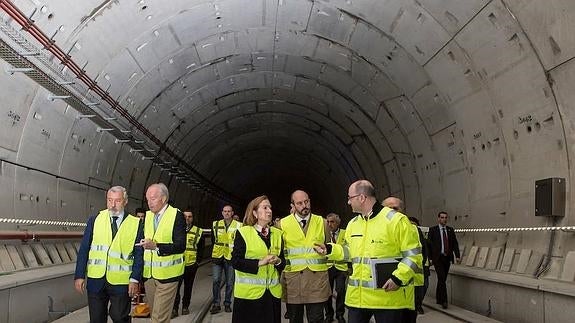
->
xmin=234 ymin=226 xmax=282 ymax=299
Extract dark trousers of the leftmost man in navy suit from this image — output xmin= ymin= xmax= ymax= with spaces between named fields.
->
xmin=88 ymin=283 xmax=132 ymax=323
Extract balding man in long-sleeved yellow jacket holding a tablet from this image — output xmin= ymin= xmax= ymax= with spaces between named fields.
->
xmin=315 ymin=180 xmax=423 ymax=323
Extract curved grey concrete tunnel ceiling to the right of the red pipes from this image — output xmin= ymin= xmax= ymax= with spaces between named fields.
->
xmin=1 ymin=0 xmax=575 ymax=233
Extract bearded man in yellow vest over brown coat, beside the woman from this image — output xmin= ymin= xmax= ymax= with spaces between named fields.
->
xmin=280 ymin=190 xmax=331 ymax=323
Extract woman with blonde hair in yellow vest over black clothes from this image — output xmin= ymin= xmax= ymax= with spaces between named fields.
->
xmin=232 ymin=195 xmax=285 ymax=323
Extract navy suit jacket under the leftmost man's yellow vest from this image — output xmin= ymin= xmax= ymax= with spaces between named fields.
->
xmin=74 ymin=214 xmax=144 ymax=294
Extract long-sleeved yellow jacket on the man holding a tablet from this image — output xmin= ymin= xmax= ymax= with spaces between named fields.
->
xmin=328 ymin=207 xmax=423 ymax=309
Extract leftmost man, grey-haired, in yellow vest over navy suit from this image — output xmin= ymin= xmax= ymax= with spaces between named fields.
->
xmin=74 ymin=186 xmax=144 ymax=323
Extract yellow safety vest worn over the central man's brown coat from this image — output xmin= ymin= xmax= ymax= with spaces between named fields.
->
xmin=281 ymin=214 xmax=327 ymax=272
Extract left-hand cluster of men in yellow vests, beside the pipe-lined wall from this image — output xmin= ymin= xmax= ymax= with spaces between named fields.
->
xmin=74 ymin=183 xmax=202 ymax=323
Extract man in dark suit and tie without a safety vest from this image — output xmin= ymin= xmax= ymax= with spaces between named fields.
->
xmin=428 ymin=211 xmax=460 ymax=308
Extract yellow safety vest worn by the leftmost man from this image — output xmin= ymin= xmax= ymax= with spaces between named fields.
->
xmin=87 ymin=209 xmax=140 ymax=285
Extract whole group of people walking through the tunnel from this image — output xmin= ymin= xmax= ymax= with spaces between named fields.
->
xmin=75 ymin=180 xmax=459 ymax=323
